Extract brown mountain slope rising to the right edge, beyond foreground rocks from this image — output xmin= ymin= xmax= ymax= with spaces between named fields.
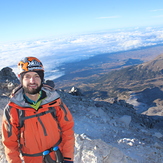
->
xmin=80 ymin=54 xmax=163 ymax=99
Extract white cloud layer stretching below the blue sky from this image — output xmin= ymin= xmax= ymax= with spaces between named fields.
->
xmin=0 ymin=27 xmax=163 ymax=78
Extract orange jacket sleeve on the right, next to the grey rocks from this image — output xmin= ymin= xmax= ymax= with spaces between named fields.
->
xmin=57 ymin=98 xmax=75 ymax=161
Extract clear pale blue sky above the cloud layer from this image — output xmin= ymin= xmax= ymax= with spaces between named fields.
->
xmin=0 ymin=0 xmax=163 ymax=42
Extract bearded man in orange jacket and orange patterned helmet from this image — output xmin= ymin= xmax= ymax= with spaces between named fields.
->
xmin=2 ymin=57 xmax=74 ymax=163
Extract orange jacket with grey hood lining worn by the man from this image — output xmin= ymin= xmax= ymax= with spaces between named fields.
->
xmin=2 ymin=86 xmax=74 ymax=163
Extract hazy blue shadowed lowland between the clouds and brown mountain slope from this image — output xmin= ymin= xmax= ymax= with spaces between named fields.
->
xmin=54 ymin=45 xmax=163 ymax=90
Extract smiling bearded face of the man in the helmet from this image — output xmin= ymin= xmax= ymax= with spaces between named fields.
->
xmin=22 ymin=72 xmax=41 ymax=95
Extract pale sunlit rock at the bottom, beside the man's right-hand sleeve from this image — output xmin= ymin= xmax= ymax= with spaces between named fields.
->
xmin=75 ymin=134 xmax=136 ymax=163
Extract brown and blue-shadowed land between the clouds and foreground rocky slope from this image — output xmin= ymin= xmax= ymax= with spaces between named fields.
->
xmin=54 ymin=45 xmax=163 ymax=116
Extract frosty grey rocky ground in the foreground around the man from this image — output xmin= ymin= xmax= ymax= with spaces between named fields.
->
xmin=0 ymin=91 xmax=163 ymax=163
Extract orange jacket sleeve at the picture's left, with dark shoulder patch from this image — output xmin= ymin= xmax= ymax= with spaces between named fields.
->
xmin=2 ymin=105 xmax=22 ymax=163
